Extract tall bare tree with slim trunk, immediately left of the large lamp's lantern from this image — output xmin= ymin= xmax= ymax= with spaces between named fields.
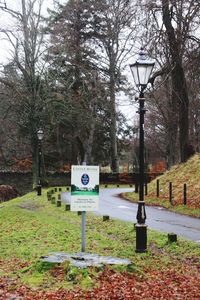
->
xmin=91 ymin=0 xmax=137 ymax=172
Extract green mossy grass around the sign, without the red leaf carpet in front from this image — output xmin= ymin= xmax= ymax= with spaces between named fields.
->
xmin=0 ymin=190 xmax=200 ymax=288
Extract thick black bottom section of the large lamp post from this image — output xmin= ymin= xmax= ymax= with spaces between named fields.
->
xmin=135 ymin=224 xmax=147 ymax=253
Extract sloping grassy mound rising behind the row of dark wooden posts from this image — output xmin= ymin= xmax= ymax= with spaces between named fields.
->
xmin=147 ymin=154 xmax=200 ymax=208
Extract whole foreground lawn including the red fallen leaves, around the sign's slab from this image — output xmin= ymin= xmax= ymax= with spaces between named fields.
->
xmin=0 ymin=168 xmax=200 ymax=300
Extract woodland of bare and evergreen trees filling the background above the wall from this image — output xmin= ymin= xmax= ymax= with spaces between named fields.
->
xmin=0 ymin=0 xmax=200 ymax=185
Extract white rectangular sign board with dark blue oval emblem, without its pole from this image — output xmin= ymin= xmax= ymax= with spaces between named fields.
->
xmin=71 ymin=166 xmax=99 ymax=211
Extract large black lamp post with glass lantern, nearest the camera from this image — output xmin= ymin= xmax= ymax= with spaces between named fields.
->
xmin=130 ymin=49 xmax=155 ymax=253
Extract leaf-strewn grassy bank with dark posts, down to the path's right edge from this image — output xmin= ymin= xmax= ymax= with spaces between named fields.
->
xmin=124 ymin=154 xmax=200 ymax=217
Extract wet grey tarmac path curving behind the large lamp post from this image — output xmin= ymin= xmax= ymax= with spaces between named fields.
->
xmin=62 ymin=188 xmax=200 ymax=243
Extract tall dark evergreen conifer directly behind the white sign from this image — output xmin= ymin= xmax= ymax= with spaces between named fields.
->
xmin=49 ymin=0 xmax=110 ymax=163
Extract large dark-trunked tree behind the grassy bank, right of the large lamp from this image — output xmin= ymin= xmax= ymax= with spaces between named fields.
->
xmin=138 ymin=0 xmax=200 ymax=163
